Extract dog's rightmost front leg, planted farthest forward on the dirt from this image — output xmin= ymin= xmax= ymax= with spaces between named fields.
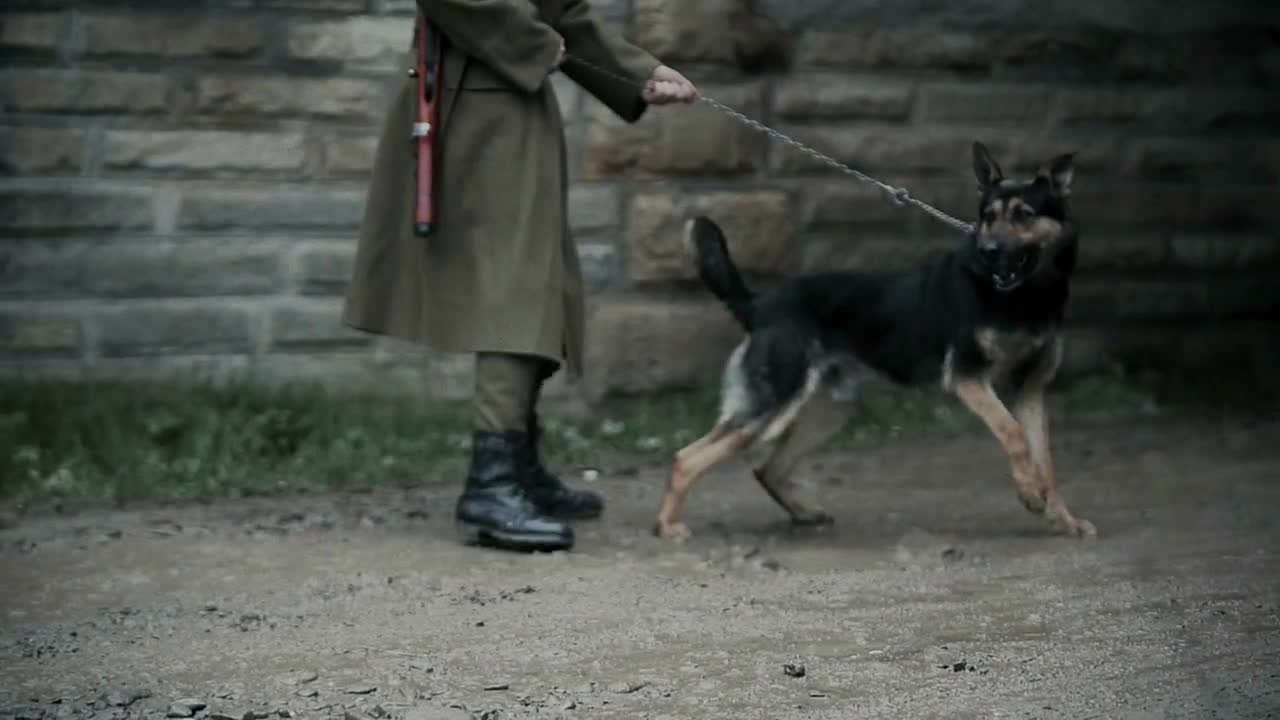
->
xmin=1011 ymin=341 xmax=1097 ymax=536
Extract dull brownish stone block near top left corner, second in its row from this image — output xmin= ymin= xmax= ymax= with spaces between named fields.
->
xmin=84 ymin=13 xmax=266 ymax=58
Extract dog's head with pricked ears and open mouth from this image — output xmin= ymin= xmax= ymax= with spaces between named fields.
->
xmin=972 ymin=142 xmax=1075 ymax=292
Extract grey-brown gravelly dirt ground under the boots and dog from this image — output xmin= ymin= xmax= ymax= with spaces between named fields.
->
xmin=0 ymin=420 xmax=1280 ymax=720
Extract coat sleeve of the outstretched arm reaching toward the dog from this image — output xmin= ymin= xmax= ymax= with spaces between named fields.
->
xmin=556 ymin=0 xmax=662 ymax=123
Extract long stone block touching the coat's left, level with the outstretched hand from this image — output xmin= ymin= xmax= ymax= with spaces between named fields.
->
xmin=195 ymin=76 xmax=390 ymax=123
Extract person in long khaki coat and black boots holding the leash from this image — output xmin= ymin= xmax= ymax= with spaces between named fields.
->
xmin=343 ymin=0 xmax=696 ymax=550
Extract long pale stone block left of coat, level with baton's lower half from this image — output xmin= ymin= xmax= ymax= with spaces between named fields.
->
xmin=102 ymin=129 xmax=306 ymax=173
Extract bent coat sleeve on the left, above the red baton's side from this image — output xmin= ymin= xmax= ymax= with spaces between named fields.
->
xmin=417 ymin=0 xmax=561 ymax=92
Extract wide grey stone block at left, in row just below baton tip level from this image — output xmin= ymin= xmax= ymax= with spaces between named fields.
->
xmin=83 ymin=238 xmax=283 ymax=297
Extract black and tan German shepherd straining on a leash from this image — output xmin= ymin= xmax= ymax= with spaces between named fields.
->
xmin=654 ymin=142 xmax=1096 ymax=538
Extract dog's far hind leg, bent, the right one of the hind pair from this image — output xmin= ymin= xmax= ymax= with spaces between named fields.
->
xmin=755 ymin=392 xmax=855 ymax=525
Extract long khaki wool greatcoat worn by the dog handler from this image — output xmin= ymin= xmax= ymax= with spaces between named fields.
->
xmin=343 ymin=0 xmax=659 ymax=375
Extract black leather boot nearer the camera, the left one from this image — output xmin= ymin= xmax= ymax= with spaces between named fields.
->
xmin=453 ymin=432 xmax=573 ymax=552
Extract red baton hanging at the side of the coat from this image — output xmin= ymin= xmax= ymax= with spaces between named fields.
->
xmin=412 ymin=10 xmax=443 ymax=237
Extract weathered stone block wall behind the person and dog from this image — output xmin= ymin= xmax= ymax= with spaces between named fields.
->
xmin=0 ymin=0 xmax=1280 ymax=396
